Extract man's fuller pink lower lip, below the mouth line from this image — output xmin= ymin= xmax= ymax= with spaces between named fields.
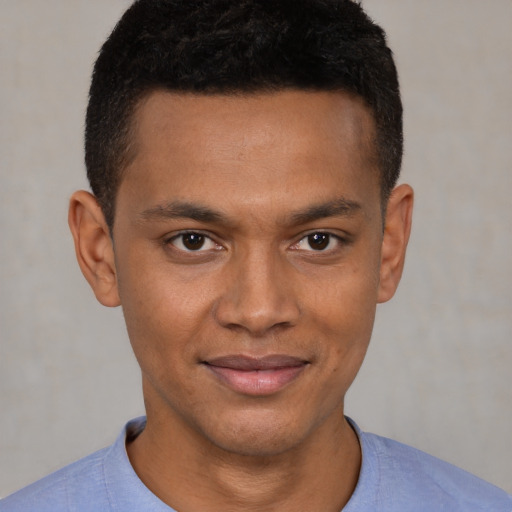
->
xmin=206 ymin=364 xmax=306 ymax=396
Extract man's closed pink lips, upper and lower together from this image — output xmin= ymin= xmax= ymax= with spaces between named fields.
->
xmin=203 ymin=354 xmax=309 ymax=396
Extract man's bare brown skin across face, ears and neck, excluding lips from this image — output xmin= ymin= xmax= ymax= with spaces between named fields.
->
xmin=69 ymin=90 xmax=412 ymax=512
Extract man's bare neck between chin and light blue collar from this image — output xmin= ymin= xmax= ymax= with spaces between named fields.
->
xmin=127 ymin=408 xmax=361 ymax=512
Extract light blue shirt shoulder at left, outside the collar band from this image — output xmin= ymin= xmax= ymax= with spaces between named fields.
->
xmin=0 ymin=448 xmax=109 ymax=512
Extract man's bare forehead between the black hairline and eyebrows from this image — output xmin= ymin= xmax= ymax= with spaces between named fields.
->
xmin=120 ymin=90 xmax=379 ymax=222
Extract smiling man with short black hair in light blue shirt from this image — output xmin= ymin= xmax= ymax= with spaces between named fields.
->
xmin=0 ymin=0 xmax=512 ymax=512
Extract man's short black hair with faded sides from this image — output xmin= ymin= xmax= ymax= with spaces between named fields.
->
xmin=85 ymin=0 xmax=403 ymax=230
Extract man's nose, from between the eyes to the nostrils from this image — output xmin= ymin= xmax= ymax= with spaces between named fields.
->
xmin=215 ymin=247 xmax=300 ymax=337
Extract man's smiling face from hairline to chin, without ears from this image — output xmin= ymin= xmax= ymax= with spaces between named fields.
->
xmin=106 ymin=91 xmax=398 ymax=454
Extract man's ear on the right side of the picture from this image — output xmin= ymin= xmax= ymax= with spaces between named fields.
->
xmin=377 ymin=185 xmax=414 ymax=303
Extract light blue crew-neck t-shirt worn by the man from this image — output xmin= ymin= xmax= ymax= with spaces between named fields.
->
xmin=0 ymin=418 xmax=512 ymax=512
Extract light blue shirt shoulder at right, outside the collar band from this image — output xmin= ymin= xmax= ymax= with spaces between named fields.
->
xmin=360 ymin=433 xmax=512 ymax=512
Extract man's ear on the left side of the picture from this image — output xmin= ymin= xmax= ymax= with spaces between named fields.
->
xmin=68 ymin=190 xmax=121 ymax=307
